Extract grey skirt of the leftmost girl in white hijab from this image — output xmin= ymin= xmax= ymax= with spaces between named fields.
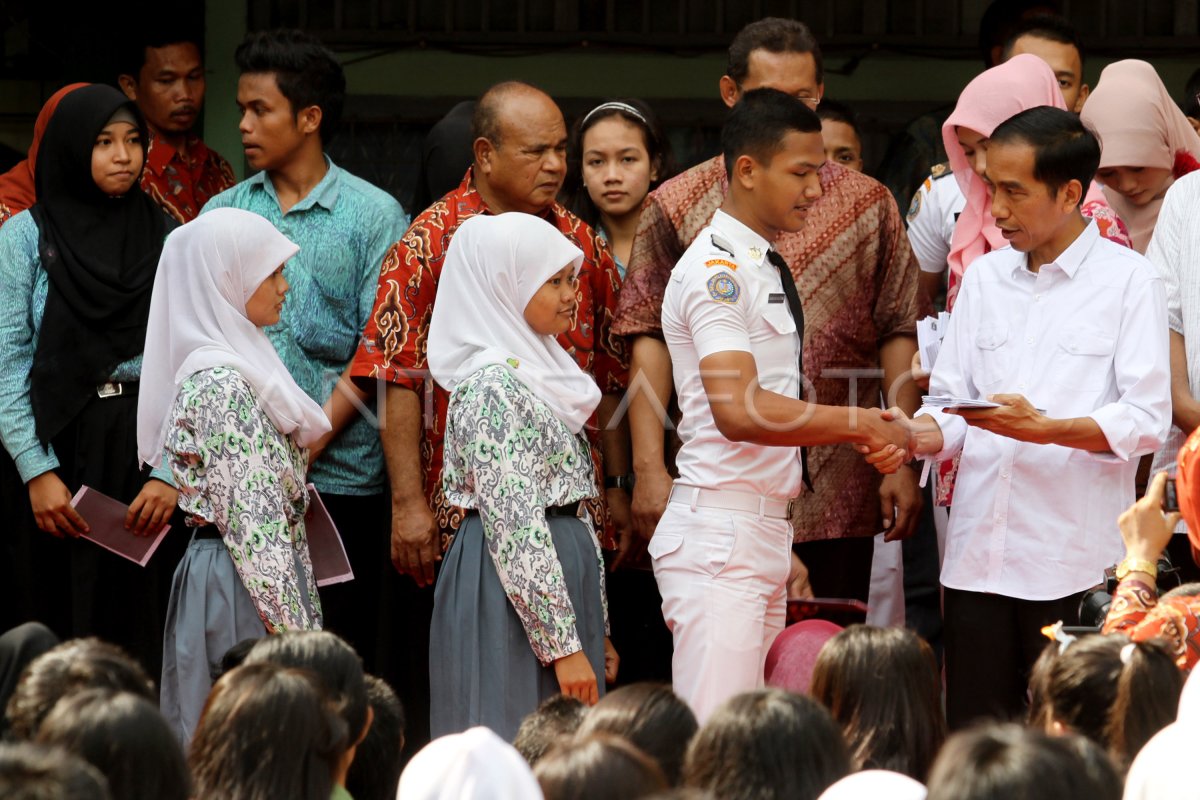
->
xmin=160 ymin=536 xmax=266 ymax=751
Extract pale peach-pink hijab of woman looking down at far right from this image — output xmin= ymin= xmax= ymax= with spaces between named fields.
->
xmin=1080 ymin=59 xmax=1200 ymax=253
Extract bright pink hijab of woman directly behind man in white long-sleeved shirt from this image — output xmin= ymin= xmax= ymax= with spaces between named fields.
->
xmin=942 ymin=53 xmax=1065 ymax=286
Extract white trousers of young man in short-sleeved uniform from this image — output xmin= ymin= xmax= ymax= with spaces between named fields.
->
xmin=649 ymin=503 xmax=792 ymax=724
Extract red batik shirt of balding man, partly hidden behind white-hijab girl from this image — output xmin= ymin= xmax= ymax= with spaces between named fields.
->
xmin=350 ymin=169 xmax=629 ymax=547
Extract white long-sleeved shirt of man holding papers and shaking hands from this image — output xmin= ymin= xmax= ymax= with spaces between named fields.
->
xmin=920 ymin=223 xmax=1171 ymax=600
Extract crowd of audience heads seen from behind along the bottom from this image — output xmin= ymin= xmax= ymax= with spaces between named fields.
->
xmin=0 ymin=625 xmax=1183 ymax=800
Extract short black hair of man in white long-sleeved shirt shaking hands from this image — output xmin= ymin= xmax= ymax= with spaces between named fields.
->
xmin=989 ymin=106 xmax=1100 ymax=201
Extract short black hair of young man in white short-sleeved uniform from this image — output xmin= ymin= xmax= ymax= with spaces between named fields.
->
xmin=721 ymin=89 xmax=821 ymax=179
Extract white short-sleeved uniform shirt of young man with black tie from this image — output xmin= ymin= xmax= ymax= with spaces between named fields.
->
xmin=662 ymin=211 xmax=803 ymax=500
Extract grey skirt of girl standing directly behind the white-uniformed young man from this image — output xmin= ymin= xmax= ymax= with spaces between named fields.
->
xmin=430 ymin=515 xmax=604 ymax=741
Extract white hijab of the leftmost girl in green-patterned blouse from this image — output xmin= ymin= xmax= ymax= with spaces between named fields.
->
xmin=138 ymin=209 xmax=330 ymax=465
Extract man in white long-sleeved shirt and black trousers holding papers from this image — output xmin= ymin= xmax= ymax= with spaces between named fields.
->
xmin=872 ymin=107 xmax=1171 ymax=728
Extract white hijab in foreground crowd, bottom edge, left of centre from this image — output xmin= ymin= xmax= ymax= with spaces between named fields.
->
xmin=396 ymin=724 xmax=542 ymax=800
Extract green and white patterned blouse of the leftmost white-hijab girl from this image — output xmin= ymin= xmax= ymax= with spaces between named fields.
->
xmin=166 ymin=367 xmax=322 ymax=633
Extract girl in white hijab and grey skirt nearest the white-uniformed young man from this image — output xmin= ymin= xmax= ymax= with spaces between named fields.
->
xmin=428 ymin=212 xmax=617 ymax=740
